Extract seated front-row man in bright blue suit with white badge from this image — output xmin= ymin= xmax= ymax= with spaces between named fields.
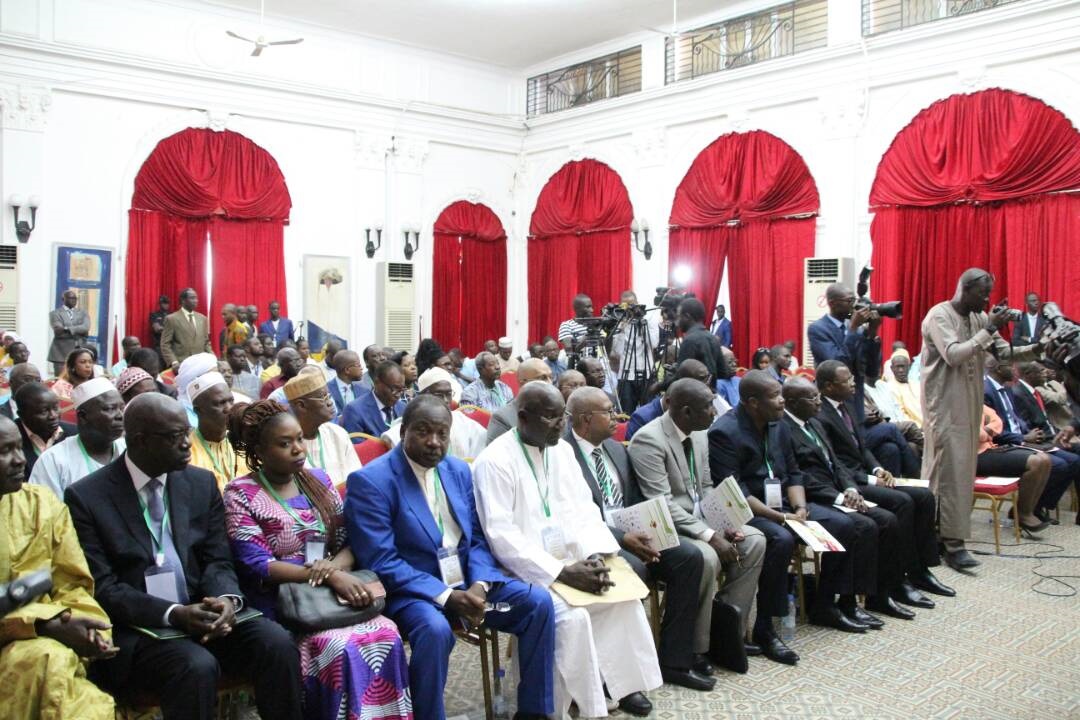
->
xmin=345 ymin=395 xmax=555 ymax=720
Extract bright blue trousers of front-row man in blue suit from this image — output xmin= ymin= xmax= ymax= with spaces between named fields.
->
xmin=391 ymin=580 xmax=555 ymax=720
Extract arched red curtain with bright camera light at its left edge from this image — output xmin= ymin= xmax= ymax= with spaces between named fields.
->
xmin=667 ymin=131 xmax=819 ymax=362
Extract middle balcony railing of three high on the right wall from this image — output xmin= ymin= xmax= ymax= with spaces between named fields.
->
xmin=664 ymin=0 xmax=829 ymax=83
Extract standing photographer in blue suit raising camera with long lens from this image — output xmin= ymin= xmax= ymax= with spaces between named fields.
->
xmin=807 ymin=283 xmax=881 ymax=422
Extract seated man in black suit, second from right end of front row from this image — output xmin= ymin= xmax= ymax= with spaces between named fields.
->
xmin=783 ymin=378 xmax=915 ymax=620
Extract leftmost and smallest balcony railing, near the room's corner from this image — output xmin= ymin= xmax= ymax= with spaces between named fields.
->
xmin=526 ymin=45 xmax=642 ymax=118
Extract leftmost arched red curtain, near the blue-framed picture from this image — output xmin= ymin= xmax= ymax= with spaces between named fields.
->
xmin=125 ymin=128 xmax=292 ymax=354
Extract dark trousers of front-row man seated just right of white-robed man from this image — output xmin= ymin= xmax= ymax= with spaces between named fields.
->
xmin=619 ymin=538 xmax=712 ymax=670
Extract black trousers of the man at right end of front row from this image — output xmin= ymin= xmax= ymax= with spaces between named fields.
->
xmin=859 ymin=485 xmax=941 ymax=574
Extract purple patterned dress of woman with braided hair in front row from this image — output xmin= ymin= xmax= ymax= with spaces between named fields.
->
xmin=225 ymin=468 xmax=413 ymax=720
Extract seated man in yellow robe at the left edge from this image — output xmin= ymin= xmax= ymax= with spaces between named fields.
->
xmin=0 ymin=418 xmax=117 ymax=720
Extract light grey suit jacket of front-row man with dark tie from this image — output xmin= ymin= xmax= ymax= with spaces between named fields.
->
xmin=630 ymin=412 xmax=712 ymax=538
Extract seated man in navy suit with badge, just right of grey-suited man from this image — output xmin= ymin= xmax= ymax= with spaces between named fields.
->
xmin=708 ymin=370 xmax=881 ymax=665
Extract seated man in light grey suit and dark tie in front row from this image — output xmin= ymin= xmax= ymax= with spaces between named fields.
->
xmin=630 ymin=378 xmax=765 ymax=654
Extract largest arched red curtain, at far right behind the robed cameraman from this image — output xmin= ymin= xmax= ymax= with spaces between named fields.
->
xmin=870 ymin=90 xmax=1080 ymax=350
